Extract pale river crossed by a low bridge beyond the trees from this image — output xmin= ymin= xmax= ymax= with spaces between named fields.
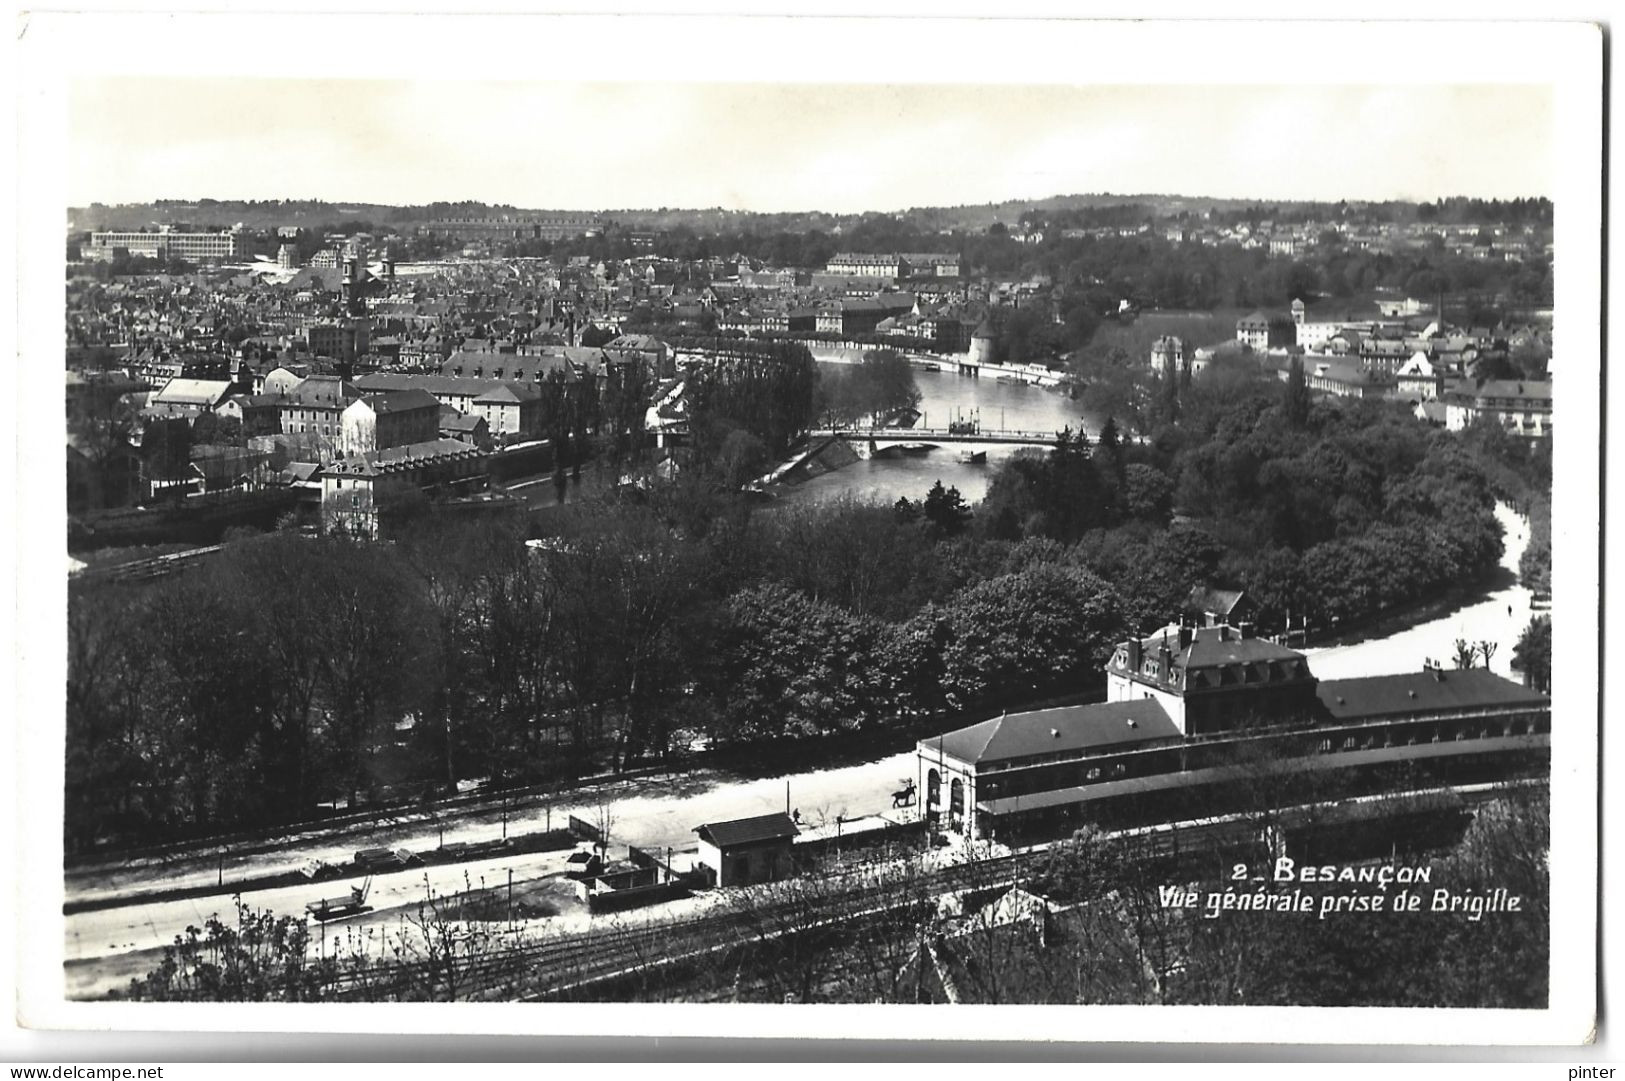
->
xmin=780 ymin=369 xmax=1100 ymax=502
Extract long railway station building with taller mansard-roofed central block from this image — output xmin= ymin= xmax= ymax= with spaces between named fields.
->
xmin=915 ymin=624 xmax=1552 ymax=839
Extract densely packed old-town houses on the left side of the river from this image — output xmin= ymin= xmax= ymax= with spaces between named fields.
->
xmin=67 ymin=223 xmax=1079 ymax=519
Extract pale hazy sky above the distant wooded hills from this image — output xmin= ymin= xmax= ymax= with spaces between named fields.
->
xmin=68 ymin=78 xmax=1552 ymax=211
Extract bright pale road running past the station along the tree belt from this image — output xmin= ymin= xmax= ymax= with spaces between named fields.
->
xmin=65 ymin=506 xmax=1531 ymax=990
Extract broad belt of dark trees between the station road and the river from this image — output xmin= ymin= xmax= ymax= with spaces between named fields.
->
xmin=67 ymin=325 xmax=1550 ymax=847
